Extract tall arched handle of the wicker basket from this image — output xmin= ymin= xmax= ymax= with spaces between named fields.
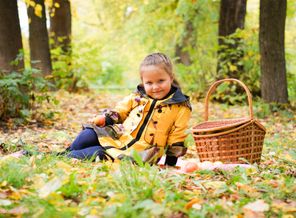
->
xmin=204 ymin=78 xmax=254 ymax=121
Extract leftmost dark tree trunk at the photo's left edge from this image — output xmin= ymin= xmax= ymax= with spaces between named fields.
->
xmin=0 ymin=0 xmax=24 ymax=73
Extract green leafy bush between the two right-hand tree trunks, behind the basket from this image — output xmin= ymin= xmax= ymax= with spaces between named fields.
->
xmin=217 ymin=29 xmax=260 ymax=96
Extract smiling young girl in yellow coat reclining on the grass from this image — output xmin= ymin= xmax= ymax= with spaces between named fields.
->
xmin=68 ymin=53 xmax=191 ymax=165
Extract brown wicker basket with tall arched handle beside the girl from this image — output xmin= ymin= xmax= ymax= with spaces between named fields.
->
xmin=192 ymin=79 xmax=266 ymax=163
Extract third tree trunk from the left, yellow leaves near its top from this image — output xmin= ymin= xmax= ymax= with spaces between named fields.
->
xmin=50 ymin=0 xmax=71 ymax=53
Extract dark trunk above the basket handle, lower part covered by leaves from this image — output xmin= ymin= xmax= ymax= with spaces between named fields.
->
xmin=217 ymin=0 xmax=247 ymax=78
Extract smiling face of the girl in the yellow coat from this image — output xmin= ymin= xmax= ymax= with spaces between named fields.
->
xmin=141 ymin=65 xmax=173 ymax=100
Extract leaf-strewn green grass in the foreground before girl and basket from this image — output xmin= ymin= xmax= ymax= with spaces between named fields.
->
xmin=0 ymin=146 xmax=296 ymax=217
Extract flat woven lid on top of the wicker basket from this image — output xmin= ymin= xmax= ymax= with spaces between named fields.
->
xmin=191 ymin=117 xmax=251 ymax=133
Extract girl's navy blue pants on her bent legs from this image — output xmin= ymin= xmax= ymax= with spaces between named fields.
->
xmin=68 ymin=129 xmax=107 ymax=160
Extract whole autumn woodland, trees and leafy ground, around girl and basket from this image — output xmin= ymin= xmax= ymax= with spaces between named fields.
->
xmin=0 ymin=0 xmax=296 ymax=218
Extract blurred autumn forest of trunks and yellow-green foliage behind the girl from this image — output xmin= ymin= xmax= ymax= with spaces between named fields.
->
xmin=0 ymin=0 xmax=296 ymax=120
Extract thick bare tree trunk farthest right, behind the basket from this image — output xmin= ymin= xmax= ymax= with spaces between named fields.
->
xmin=259 ymin=0 xmax=288 ymax=103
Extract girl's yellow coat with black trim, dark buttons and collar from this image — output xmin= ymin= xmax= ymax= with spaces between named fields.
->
xmin=87 ymin=86 xmax=191 ymax=163
